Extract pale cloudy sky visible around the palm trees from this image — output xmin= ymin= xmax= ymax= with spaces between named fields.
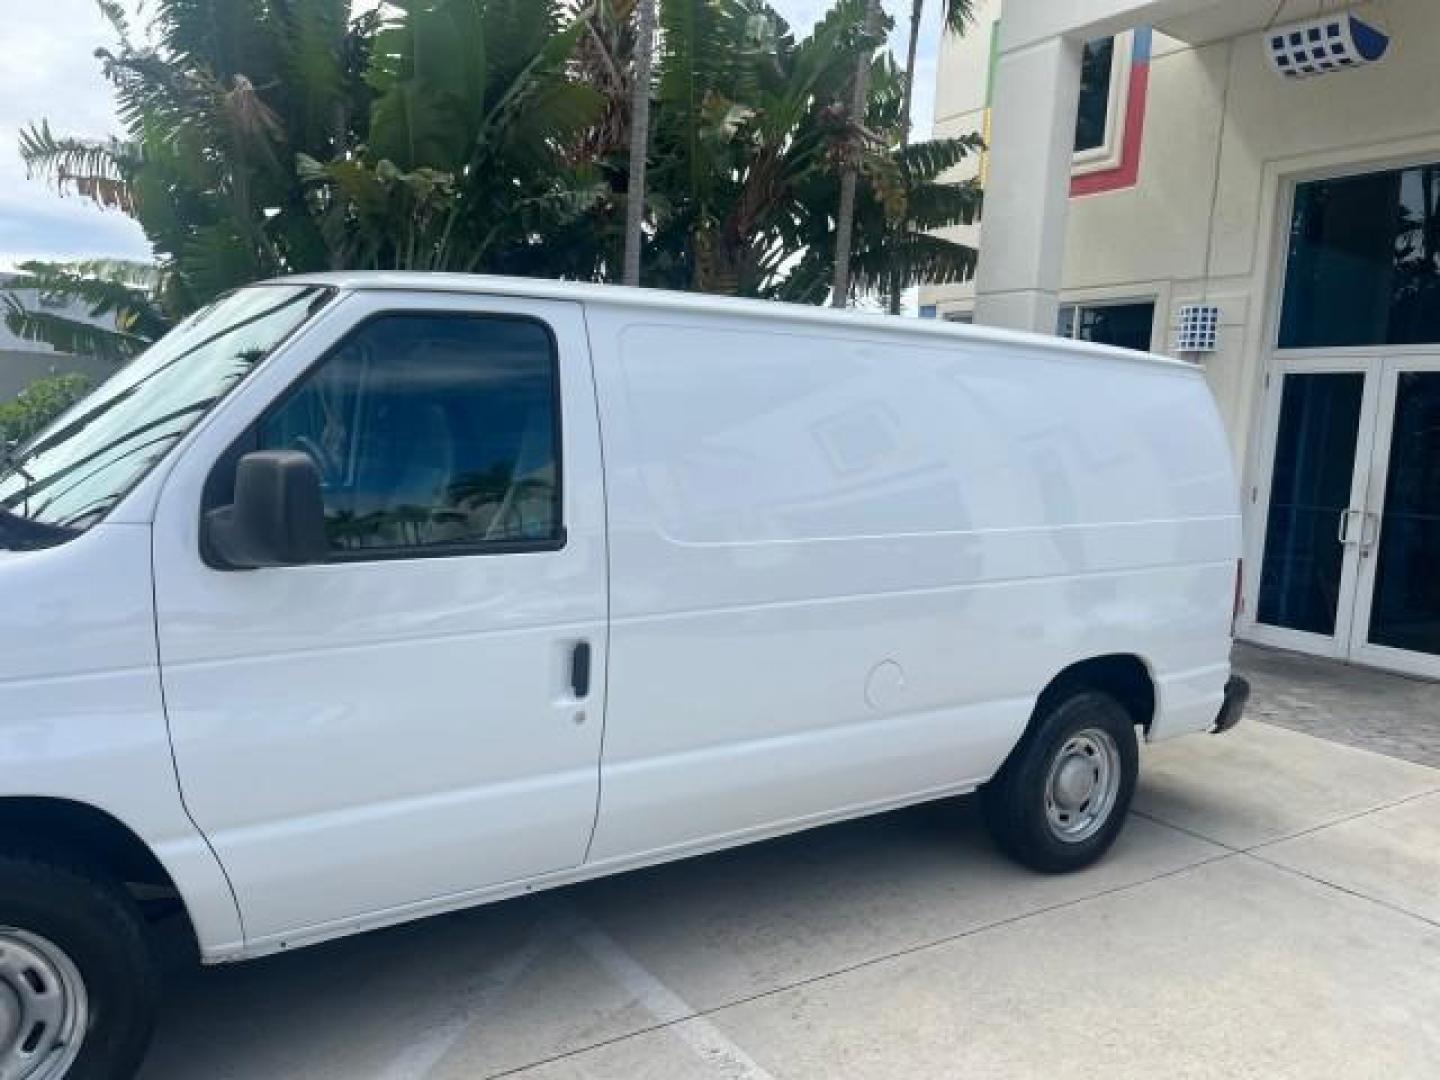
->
xmin=0 ymin=0 xmax=940 ymax=269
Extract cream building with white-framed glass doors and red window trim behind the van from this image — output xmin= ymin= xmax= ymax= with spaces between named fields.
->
xmin=922 ymin=0 xmax=1440 ymax=675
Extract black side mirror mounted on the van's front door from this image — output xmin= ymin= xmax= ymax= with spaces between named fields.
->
xmin=203 ymin=451 xmax=330 ymax=570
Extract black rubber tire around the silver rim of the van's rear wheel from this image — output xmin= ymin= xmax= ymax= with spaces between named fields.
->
xmin=981 ymin=690 xmax=1140 ymax=874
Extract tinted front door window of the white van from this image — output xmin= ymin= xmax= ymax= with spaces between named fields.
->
xmin=258 ymin=314 xmax=563 ymax=559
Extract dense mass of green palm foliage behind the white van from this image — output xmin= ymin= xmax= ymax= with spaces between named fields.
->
xmin=6 ymin=0 xmax=979 ymax=332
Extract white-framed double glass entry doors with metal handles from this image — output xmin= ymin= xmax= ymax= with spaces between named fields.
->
xmin=1246 ymin=356 xmax=1440 ymax=677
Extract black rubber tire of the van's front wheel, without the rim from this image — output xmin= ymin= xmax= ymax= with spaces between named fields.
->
xmin=0 ymin=852 xmax=160 ymax=1080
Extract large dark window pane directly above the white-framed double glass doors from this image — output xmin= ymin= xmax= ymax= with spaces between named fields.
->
xmin=1280 ymin=164 xmax=1440 ymax=348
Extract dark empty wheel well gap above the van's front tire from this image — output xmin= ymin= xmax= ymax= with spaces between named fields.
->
xmin=0 ymin=798 xmax=179 ymax=894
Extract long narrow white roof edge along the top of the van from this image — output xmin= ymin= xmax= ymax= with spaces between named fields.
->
xmin=265 ymin=271 xmax=1200 ymax=374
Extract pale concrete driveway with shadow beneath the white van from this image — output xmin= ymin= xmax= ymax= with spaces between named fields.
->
xmin=144 ymin=721 xmax=1440 ymax=1080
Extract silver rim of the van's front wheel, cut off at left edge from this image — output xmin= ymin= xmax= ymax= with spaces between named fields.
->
xmin=0 ymin=926 xmax=89 ymax=1080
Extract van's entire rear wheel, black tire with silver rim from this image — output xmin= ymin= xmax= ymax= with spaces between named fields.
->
xmin=981 ymin=690 xmax=1139 ymax=873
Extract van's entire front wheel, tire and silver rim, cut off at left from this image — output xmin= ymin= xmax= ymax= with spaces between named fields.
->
xmin=0 ymin=854 xmax=158 ymax=1080
